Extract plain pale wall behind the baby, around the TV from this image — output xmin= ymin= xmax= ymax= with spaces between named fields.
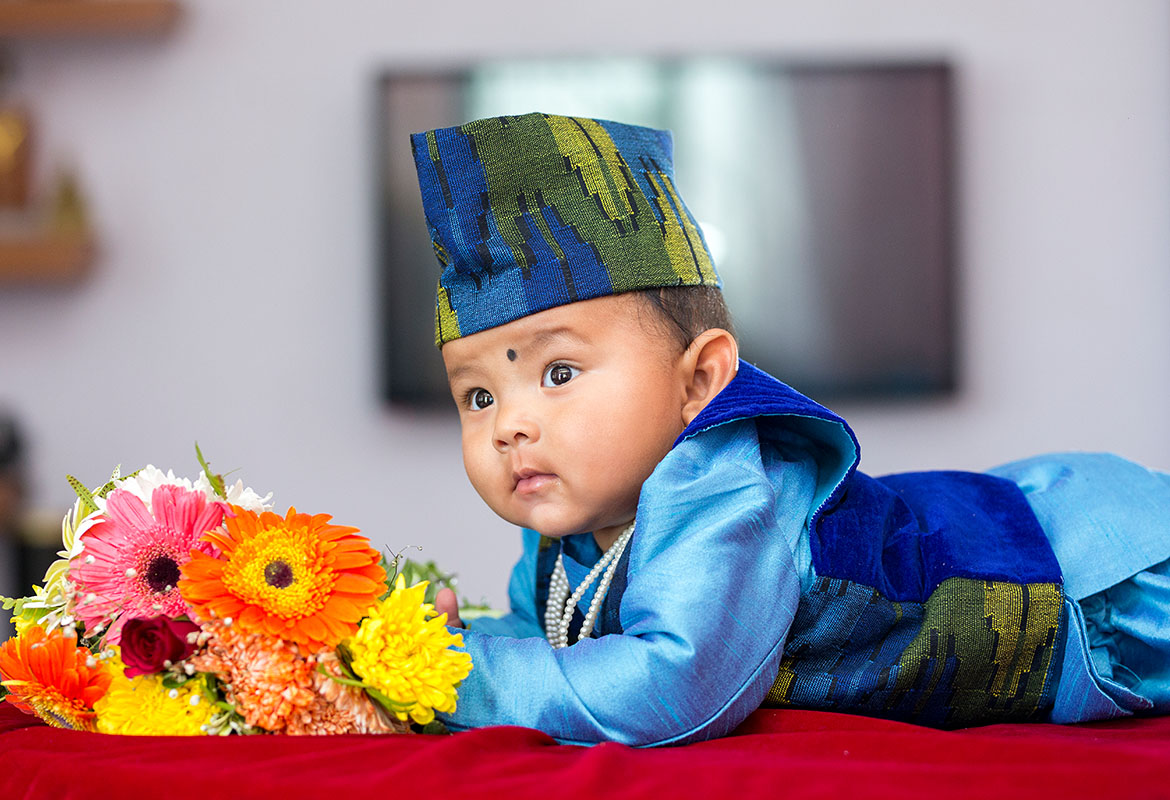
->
xmin=0 ymin=0 xmax=1170 ymax=602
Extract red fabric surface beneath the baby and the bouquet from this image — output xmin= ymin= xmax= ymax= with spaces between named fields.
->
xmin=0 ymin=703 xmax=1170 ymax=800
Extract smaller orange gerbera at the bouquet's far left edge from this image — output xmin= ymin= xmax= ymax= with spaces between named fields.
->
xmin=0 ymin=625 xmax=111 ymax=731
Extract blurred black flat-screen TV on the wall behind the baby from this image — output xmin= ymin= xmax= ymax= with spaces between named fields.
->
xmin=377 ymin=57 xmax=956 ymax=406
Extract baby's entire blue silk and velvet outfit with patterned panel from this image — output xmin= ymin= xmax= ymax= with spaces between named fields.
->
xmin=442 ymin=363 xmax=1170 ymax=745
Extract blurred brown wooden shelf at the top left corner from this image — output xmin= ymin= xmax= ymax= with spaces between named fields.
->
xmin=0 ymin=0 xmax=179 ymax=39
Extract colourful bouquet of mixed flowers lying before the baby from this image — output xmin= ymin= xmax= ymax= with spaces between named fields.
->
xmin=0 ymin=447 xmax=472 ymax=736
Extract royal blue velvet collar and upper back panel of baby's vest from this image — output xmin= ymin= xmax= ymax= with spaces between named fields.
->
xmin=676 ymin=361 xmax=1061 ymax=601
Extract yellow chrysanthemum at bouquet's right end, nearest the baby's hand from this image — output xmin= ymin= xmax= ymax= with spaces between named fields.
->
xmin=347 ymin=574 xmax=472 ymax=725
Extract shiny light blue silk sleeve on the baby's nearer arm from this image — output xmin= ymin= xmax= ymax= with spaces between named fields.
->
xmin=442 ymin=421 xmax=817 ymax=745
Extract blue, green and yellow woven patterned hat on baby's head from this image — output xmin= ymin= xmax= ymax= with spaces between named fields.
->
xmin=411 ymin=113 xmax=720 ymax=347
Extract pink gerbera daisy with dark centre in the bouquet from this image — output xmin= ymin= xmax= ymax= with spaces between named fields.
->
xmin=69 ymin=485 xmax=225 ymax=644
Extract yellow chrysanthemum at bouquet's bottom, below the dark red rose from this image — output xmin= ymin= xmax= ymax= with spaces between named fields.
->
xmin=94 ymin=656 xmax=215 ymax=736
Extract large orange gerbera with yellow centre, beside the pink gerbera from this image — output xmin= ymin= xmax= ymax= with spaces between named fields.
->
xmin=179 ymin=505 xmax=386 ymax=651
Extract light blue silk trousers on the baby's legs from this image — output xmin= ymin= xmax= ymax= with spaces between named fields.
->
xmin=992 ymin=453 xmax=1170 ymax=722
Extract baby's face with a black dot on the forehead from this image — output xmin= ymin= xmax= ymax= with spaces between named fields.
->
xmin=442 ymin=295 xmax=686 ymax=542
